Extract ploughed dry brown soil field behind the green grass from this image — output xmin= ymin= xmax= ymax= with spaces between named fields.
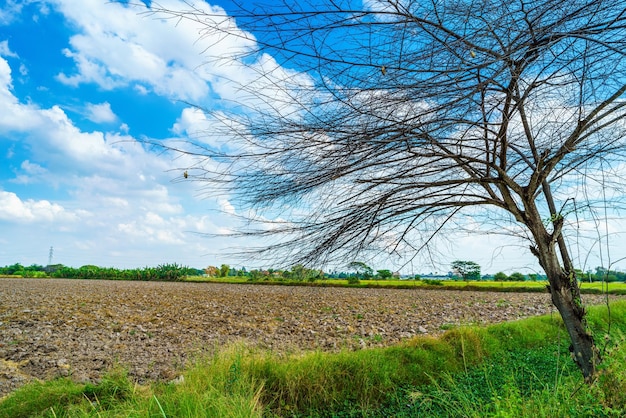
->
xmin=0 ymin=279 xmax=612 ymax=397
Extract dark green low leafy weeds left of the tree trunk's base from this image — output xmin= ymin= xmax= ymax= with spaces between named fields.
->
xmin=368 ymin=347 xmax=576 ymax=417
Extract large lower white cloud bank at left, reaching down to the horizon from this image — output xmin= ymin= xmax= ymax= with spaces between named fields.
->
xmin=0 ymin=49 xmax=246 ymax=266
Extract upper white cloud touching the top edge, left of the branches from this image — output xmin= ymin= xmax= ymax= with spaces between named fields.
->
xmin=48 ymin=0 xmax=311 ymax=108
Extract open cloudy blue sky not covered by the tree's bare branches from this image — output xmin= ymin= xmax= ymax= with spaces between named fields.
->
xmin=0 ymin=0 xmax=616 ymax=273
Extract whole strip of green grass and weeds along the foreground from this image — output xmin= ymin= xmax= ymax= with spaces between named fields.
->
xmin=0 ymin=301 xmax=626 ymax=418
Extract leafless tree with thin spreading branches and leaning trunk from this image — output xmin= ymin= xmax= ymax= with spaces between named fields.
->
xmin=144 ymin=0 xmax=626 ymax=380
